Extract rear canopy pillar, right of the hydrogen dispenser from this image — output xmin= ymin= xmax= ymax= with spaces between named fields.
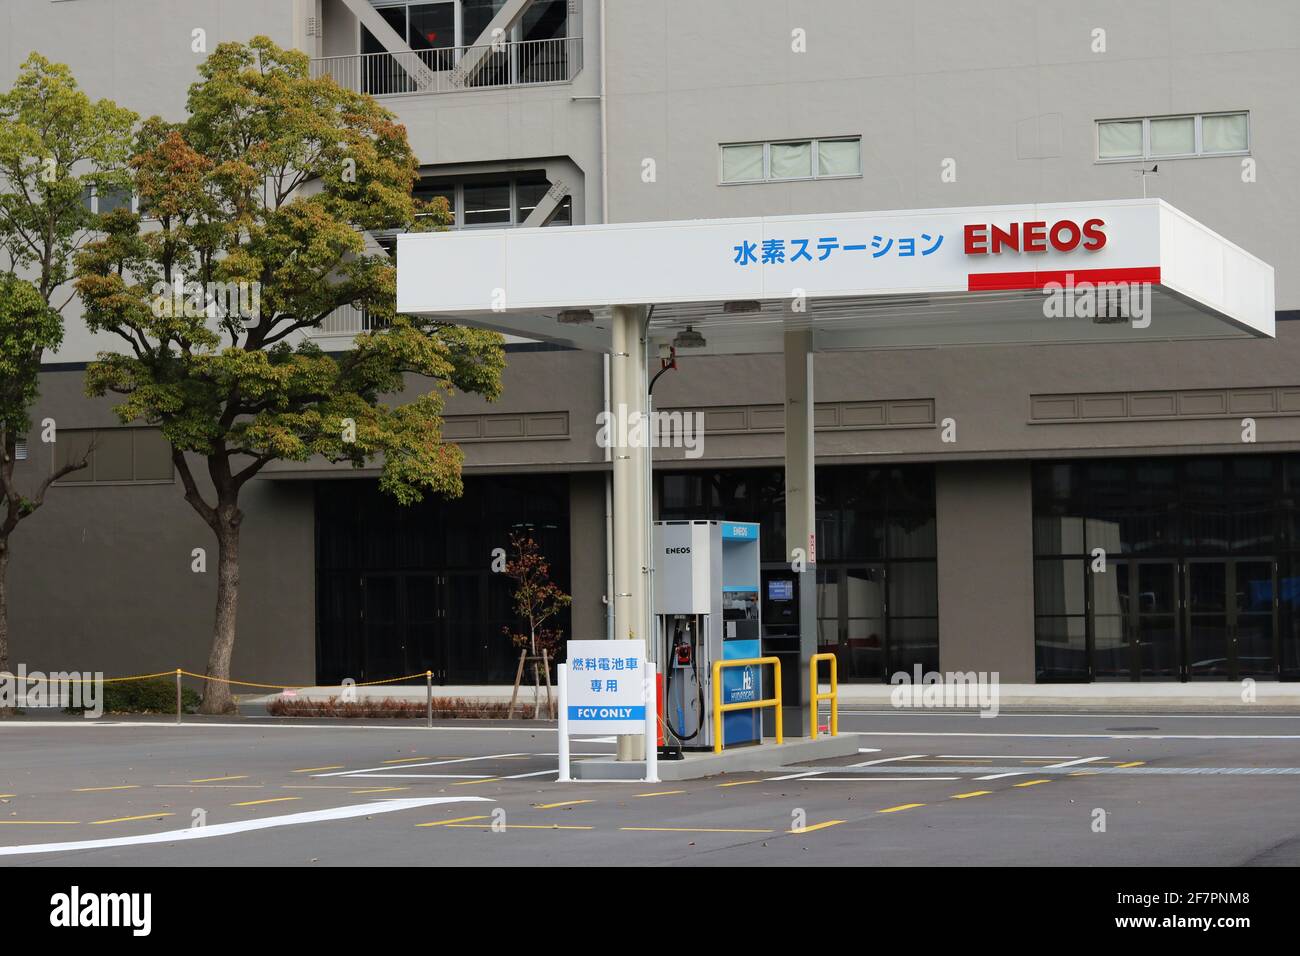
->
xmin=783 ymin=329 xmax=816 ymax=736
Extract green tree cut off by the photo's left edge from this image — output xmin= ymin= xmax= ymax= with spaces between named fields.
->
xmin=0 ymin=53 xmax=135 ymax=671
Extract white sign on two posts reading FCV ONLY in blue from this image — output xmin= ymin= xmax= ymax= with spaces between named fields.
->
xmin=558 ymin=640 xmax=659 ymax=783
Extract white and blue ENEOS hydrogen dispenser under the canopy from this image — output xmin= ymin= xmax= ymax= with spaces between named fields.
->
xmin=654 ymin=522 xmax=763 ymax=756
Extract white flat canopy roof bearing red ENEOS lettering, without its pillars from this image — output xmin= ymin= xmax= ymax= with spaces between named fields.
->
xmin=398 ymin=199 xmax=1274 ymax=354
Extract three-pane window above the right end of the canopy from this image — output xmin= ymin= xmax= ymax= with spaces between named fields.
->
xmin=1097 ymin=113 xmax=1251 ymax=161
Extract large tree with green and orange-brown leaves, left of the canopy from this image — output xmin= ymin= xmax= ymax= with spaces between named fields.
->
xmin=77 ymin=36 xmax=504 ymax=713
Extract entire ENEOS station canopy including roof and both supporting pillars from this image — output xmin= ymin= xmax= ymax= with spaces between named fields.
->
xmin=397 ymin=199 xmax=1274 ymax=761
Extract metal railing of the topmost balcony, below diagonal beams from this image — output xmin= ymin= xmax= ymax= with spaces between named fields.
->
xmin=312 ymin=36 xmax=582 ymax=96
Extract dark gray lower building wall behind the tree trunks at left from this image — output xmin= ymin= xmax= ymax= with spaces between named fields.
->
xmin=9 ymin=371 xmax=316 ymax=682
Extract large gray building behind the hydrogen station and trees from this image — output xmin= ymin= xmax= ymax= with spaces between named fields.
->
xmin=0 ymin=0 xmax=1300 ymax=684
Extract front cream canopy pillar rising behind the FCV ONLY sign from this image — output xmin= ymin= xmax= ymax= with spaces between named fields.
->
xmin=610 ymin=306 xmax=654 ymax=760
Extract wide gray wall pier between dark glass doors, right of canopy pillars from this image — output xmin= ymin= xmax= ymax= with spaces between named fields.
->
xmin=935 ymin=462 xmax=1034 ymax=684
